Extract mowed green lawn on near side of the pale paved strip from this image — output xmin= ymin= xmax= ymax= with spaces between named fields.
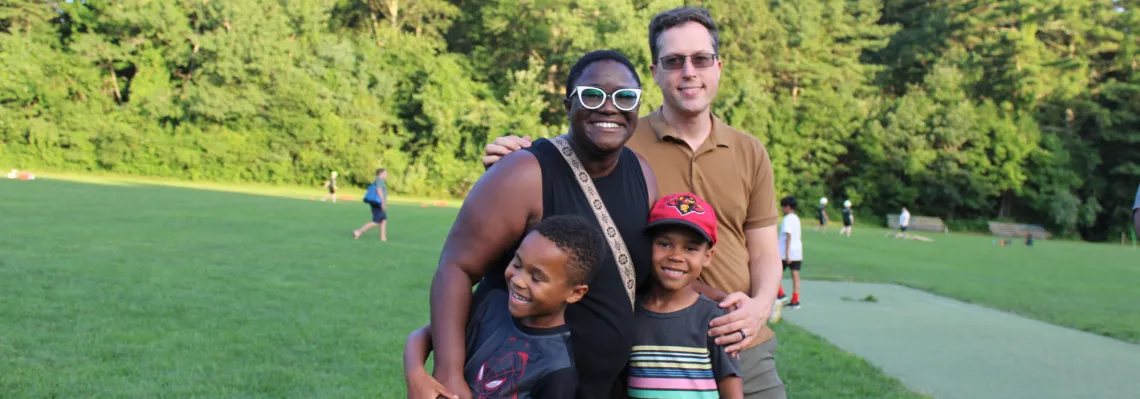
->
xmin=0 ymin=178 xmax=921 ymax=398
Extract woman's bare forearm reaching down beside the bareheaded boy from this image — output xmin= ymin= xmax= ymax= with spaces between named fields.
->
xmin=430 ymin=268 xmax=472 ymax=384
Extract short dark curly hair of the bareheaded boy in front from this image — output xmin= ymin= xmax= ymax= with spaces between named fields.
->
xmin=532 ymin=214 xmax=606 ymax=285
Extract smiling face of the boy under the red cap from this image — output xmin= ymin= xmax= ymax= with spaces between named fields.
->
xmin=652 ymin=227 xmax=715 ymax=292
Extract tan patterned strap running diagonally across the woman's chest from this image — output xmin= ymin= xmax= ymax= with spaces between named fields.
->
xmin=551 ymin=136 xmax=634 ymax=308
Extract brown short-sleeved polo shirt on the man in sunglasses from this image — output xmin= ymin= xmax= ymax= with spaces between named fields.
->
xmin=626 ymin=108 xmax=780 ymax=342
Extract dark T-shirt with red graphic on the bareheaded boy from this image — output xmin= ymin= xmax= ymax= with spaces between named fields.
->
xmin=463 ymin=290 xmax=578 ymax=399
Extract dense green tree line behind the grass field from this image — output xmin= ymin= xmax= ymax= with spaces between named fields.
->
xmin=0 ymin=0 xmax=1140 ymax=239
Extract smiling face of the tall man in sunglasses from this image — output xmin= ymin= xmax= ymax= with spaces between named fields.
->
xmin=650 ymin=22 xmax=723 ymax=115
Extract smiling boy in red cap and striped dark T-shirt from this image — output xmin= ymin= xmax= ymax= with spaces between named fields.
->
xmin=627 ymin=193 xmax=743 ymax=399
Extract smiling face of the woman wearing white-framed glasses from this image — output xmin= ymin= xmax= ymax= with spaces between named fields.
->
xmin=564 ymin=59 xmax=641 ymax=154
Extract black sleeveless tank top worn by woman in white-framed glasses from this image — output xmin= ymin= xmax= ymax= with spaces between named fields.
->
xmin=477 ymin=139 xmax=652 ymax=399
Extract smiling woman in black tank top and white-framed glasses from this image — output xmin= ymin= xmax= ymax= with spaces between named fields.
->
xmin=409 ymin=51 xmax=658 ymax=399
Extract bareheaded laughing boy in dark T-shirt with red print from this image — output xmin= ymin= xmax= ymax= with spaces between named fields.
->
xmin=404 ymin=215 xmax=608 ymax=399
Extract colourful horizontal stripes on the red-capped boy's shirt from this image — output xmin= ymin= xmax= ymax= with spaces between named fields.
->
xmin=628 ymin=345 xmax=720 ymax=399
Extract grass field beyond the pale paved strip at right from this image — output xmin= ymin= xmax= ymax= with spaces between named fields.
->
xmin=802 ymin=219 xmax=1140 ymax=343
